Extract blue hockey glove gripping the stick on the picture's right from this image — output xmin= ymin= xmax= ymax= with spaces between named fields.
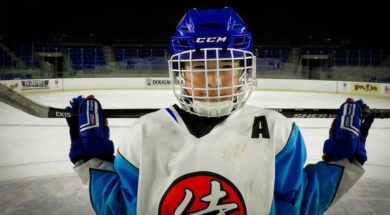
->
xmin=323 ymin=99 xmax=374 ymax=164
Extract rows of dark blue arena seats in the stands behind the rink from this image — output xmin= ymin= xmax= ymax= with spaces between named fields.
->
xmin=0 ymin=42 xmax=390 ymax=77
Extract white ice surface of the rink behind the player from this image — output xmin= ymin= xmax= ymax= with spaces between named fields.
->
xmin=0 ymin=90 xmax=390 ymax=215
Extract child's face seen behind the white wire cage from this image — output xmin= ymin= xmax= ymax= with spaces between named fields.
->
xmin=183 ymin=60 xmax=242 ymax=102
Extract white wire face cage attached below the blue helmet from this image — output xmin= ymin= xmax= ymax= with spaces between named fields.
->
xmin=168 ymin=48 xmax=256 ymax=117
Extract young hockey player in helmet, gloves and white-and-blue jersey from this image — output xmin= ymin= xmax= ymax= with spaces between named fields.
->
xmin=68 ymin=7 xmax=373 ymax=215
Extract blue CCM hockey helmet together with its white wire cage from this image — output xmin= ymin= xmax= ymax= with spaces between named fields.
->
xmin=168 ymin=7 xmax=256 ymax=117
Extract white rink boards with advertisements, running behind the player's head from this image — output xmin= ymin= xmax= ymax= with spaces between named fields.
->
xmin=1 ymin=78 xmax=390 ymax=97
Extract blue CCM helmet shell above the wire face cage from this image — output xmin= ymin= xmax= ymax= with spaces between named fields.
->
xmin=170 ymin=7 xmax=252 ymax=55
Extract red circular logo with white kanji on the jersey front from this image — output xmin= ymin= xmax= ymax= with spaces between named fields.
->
xmin=159 ymin=172 xmax=246 ymax=215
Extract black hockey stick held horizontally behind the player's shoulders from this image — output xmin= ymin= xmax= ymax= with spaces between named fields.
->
xmin=0 ymin=84 xmax=390 ymax=119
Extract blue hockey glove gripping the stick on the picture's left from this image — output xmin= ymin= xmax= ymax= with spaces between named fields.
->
xmin=66 ymin=96 xmax=114 ymax=163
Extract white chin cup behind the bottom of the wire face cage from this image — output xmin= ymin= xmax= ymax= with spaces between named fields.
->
xmin=192 ymin=100 xmax=234 ymax=117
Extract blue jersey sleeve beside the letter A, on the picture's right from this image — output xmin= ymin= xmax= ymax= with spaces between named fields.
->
xmin=271 ymin=124 xmax=364 ymax=214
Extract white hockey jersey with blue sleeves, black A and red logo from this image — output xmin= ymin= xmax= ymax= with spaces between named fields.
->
xmin=75 ymin=106 xmax=364 ymax=215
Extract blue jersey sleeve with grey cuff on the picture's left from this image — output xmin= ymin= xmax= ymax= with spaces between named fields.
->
xmin=76 ymin=154 xmax=139 ymax=215
